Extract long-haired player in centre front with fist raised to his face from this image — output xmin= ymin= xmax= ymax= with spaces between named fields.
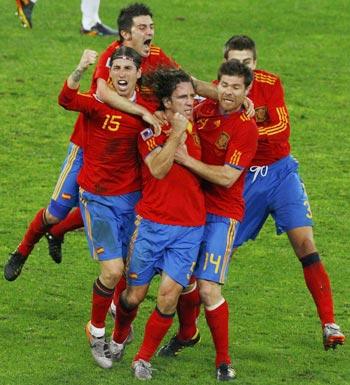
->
xmin=110 ymin=69 xmax=205 ymax=380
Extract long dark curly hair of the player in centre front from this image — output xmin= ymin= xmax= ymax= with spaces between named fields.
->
xmin=142 ymin=67 xmax=194 ymax=110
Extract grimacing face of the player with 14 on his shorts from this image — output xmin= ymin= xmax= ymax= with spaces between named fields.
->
xmin=217 ymin=75 xmax=247 ymax=113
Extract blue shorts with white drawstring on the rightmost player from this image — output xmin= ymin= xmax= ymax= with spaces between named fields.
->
xmin=234 ymin=156 xmax=313 ymax=247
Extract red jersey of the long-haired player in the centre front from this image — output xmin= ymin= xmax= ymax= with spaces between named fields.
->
xmin=136 ymin=122 xmax=206 ymax=226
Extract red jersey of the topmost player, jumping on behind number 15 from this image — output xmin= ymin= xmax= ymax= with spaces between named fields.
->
xmin=70 ymin=41 xmax=177 ymax=147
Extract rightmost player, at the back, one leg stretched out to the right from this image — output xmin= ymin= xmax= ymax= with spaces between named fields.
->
xmin=224 ymin=35 xmax=345 ymax=350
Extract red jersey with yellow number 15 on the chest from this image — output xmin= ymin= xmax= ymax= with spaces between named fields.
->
xmin=59 ymin=83 xmax=150 ymax=195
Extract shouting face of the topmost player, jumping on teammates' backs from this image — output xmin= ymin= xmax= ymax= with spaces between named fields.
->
xmin=123 ymin=16 xmax=154 ymax=57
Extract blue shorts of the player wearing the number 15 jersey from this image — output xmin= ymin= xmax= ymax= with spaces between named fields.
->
xmin=80 ymin=189 xmax=141 ymax=261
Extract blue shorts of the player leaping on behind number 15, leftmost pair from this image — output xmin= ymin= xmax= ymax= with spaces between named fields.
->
xmin=48 ymin=143 xmax=83 ymax=219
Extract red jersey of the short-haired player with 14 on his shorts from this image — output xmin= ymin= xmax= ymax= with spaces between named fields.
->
xmin=194 ymin=99 xmax=258 ymax=221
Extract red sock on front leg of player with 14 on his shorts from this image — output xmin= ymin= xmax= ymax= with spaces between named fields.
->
xmin=205 ymin=301 xmax=231 ymax=367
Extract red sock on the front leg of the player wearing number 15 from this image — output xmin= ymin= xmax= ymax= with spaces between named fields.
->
xmin=91 ymin=278 xmax=114 ymax=328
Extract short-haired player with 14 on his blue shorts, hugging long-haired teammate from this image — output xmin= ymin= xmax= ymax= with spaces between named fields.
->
xmin=159 ymin=60 xmax=258 ymax=381
